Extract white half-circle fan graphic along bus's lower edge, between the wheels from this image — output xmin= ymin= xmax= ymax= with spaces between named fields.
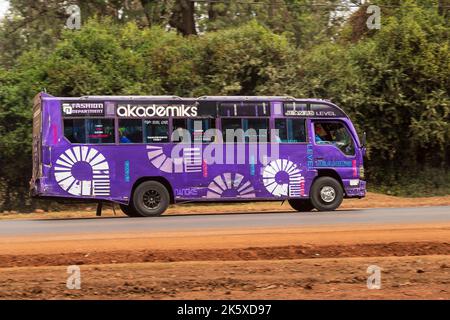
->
xmin=206 ymin=172 xmax=256 ymax=198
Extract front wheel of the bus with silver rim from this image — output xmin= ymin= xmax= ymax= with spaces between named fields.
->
xmin=310 ymin=177 xmax=344 ymax=211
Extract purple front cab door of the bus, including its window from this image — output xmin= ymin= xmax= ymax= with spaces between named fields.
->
xmin=311 ymin=120 xmax=358 ymax=179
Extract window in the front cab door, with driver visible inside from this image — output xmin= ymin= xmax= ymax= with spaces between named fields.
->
xmin=314 ymin=121 xmax=355 ymax=155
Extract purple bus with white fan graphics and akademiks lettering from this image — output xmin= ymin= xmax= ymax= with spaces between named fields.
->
xmin=30 ymin=93 xmax=366 ymax=217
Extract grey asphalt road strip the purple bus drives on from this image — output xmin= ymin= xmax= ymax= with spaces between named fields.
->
xmin=0 ymin=206 xmax=450 ymax=237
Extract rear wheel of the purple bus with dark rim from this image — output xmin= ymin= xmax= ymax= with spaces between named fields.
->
xmin=133 ymin=181 xmax=170 ymax=217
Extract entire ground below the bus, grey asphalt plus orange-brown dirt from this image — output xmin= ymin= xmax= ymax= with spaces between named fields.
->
xmin=0 ymin=207 xmax=450 ymax=299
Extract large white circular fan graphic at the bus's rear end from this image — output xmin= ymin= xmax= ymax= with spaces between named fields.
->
xmin=55 ymin=147 xmax=110 ymax=196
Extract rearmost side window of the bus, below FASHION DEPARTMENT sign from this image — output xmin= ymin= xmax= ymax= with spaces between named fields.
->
xmin=64 ymin=119 xmax=115 ymax=143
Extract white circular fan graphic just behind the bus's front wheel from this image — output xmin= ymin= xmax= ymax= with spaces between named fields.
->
xmin=263 ymin=159 xmax=305 ymax=197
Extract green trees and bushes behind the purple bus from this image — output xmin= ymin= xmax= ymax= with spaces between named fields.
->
xmin=0 ymin=0 xmax=450 ymax=212
